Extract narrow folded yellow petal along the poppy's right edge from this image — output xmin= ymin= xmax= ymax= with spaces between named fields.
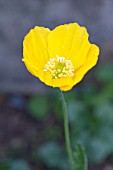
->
xmin=60 ymin=44 xmax=99 ymax=91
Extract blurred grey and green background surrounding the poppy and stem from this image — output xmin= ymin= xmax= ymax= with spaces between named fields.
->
xmin=0 ymin=0 xmax=113 ymax=170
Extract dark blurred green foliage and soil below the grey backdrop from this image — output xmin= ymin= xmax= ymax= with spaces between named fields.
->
xmin=0 ymin=63 xmax=113 ymax=170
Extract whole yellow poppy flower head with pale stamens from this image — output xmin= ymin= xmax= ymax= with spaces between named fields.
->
xmin=22 ymin=23 xmax=99 ymax=91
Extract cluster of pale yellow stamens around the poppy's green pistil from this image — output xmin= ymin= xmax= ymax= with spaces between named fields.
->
xmin=43 ymin=55 xmax=74 ymax=79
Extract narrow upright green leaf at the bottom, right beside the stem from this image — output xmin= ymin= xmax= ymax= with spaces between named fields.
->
xmin=74 ymin=143 xmax=88 ymax=170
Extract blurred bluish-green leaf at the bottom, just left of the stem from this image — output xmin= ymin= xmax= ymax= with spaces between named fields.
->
xmin=38 ymin=142 xmax=69 ymax=170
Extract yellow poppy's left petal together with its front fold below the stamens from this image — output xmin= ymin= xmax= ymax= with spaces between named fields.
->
xmin=23 ymin=27 xmax=72 ymax=87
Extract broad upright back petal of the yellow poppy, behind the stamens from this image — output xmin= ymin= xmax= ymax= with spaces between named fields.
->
xmin=47 ymin=23 xmax=90 ymax=69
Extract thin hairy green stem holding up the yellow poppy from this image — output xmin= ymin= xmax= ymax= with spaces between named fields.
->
xmin=60 ymin=91 xmax=74 ymax=170
